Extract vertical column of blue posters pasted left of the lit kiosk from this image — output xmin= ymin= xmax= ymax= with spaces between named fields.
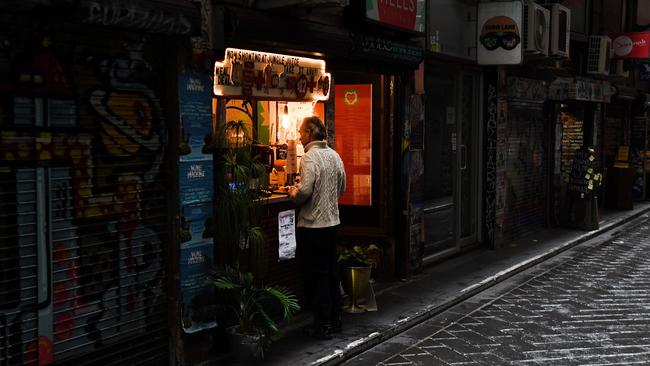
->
xmin=178 ymin=74 xmax=217 ymax=333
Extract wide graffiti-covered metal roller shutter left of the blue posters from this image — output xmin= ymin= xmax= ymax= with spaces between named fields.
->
xmin=50 ymin=28 xmax=169 ymax=365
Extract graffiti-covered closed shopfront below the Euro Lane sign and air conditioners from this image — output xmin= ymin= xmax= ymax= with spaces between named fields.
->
xmin=495 ymin=77 xmax=548 ymax=246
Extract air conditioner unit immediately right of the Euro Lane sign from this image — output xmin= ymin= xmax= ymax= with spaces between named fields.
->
xmin=523 ymin=0 xmax=551 ymax=55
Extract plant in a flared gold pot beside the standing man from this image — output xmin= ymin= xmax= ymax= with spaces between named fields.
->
xmin=338 ymin=244 xmax=381 ymax=313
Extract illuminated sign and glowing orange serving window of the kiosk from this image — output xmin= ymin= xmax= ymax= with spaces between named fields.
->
xmin=213 ymin=48 xmax=331 ymax=188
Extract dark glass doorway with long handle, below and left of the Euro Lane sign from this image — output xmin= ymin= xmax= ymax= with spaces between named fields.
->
xmin=423 ymin=69 xmax=481 ymax=261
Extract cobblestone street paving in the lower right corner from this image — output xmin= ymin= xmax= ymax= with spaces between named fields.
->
xmin=346 ymin=221 xmax=650 ymax=366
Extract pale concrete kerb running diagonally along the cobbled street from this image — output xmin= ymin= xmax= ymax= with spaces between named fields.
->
xmin=311 ymin=206 xmax=650 ymax=366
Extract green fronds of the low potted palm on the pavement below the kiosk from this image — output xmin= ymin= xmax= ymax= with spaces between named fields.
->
xmin=208 ymin=265 xmax=300 ymax=342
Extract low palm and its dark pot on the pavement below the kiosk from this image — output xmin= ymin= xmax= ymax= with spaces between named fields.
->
xmin=208 ymin=266 xmax=300 ymax=363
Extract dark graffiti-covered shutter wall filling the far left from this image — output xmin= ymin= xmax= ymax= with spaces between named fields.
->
xmin=0 ymin=21 xmax=168 ymax=364
